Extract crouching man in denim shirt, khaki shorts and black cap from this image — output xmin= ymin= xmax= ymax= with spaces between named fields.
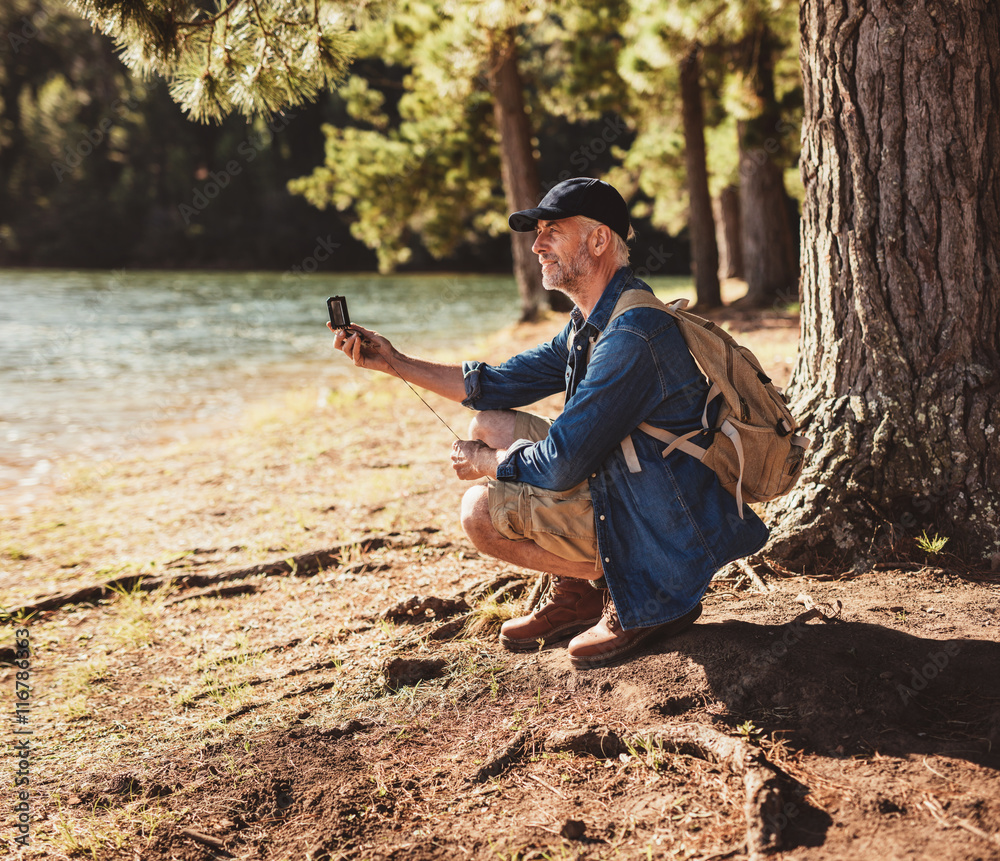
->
xmin=335 ymin=177 xmax=768 ymax=668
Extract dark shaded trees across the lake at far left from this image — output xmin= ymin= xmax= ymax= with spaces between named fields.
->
xmin=0 ymin=0 xmax=380 ymax=270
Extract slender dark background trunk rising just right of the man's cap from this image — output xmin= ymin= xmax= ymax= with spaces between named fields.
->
xmin=681 ymin=45 xmax=722 ymax=309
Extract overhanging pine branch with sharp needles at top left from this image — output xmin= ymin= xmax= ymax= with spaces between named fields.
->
xmin=70 ymin=0 xmax=381 ymax=122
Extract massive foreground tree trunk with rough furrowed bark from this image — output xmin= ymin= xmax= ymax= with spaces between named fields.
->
xmin=767 ymin=5 xmax=1000 ymax=570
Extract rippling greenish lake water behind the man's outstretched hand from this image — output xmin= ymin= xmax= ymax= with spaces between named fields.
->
xmin=0 ymin=270 xmax=519 ymax=504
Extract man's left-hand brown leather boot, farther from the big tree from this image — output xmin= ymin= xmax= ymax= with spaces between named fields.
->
xmin=500 ymin=577 xmax=607 ymax=652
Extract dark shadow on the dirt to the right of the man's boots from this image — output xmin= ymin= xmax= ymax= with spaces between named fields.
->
xmin=568 ymin=620 xmax=1000 ymax=768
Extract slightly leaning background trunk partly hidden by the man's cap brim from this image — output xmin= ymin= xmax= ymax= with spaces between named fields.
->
xmin=490 ymin=30 xmax=544 ymax=321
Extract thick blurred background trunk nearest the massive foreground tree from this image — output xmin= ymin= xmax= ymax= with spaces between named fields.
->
xmin=739 ymin=24 xmax=799 ymax=308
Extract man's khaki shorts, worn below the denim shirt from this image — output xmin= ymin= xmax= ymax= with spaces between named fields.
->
xmin=489 ymin=411 xmax=597 ymax=564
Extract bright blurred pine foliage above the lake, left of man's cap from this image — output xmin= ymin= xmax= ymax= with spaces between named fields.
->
xmin=289 ymin=0 xmax=626 ymax=271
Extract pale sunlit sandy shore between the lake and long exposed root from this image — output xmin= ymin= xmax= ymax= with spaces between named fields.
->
xmin=0 ymin=319 xmax=561 ymax=606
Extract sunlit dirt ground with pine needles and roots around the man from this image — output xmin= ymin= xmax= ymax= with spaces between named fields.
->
xmin=0 ymin=302 xmax=1000 ymax=861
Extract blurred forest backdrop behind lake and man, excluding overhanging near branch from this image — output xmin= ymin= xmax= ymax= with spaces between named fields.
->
xmin=0 ymin=0 xmax=802 ymax=317
